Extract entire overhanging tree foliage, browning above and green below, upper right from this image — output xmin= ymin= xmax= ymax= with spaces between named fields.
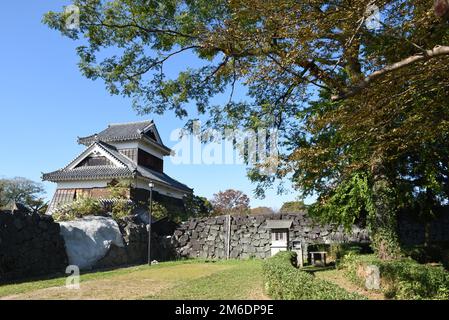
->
xmin=44 ymin=0 xmax=449 ymax=256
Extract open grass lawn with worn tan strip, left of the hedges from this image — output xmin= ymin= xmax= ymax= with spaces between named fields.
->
xmin=0 ymin=260 xmax=266 ymax=299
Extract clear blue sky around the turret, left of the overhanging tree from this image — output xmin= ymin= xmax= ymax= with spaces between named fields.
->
xmin=0 ymin=0 xmax=304 ymax=208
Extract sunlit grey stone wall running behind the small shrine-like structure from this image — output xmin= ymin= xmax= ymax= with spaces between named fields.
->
xmin=172 ymin=213 xmax=369 ymax=259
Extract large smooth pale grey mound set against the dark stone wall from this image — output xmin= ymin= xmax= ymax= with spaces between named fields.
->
xmin=60 ymin=216 xmax=124 ymax=269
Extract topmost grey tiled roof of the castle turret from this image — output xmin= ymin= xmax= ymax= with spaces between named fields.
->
xmin=78 ymin=120 xmax=171 ymax=153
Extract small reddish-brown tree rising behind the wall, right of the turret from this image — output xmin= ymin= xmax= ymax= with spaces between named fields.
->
xmin=211 ymin=189 xmax=250 ymax=215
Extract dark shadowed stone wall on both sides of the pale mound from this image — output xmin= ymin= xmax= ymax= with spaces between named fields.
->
xmin=0 ymin=211 xmax=175 ymax=283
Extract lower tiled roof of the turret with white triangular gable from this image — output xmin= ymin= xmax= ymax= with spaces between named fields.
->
xmin=42 ymin=141 xmax=192 ymax=193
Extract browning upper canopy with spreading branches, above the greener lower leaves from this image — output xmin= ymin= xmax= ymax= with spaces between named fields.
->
xmin=44 ymin=0 xmax=449 ymax=173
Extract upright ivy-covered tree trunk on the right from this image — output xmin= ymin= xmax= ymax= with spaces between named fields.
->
xmin=370 ymin=157 xmax=401 ymax=260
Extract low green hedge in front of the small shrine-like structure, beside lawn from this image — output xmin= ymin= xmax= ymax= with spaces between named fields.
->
xmin=263 ymin=251 xmax=364 ymax=300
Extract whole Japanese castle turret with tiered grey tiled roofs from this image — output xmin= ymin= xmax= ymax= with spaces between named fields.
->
xmin=42 ymin=121 xmax=193 ymax=214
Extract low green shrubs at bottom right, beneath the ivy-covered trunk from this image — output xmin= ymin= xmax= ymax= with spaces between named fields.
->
xmin=341 ymin=252 xmax=449 ymax=300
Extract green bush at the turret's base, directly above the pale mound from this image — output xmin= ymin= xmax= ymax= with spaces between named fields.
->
xmin=53 ymin=197 xmax=106 ymax=221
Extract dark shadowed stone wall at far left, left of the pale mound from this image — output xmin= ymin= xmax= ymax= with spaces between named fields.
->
xmin=0 ymin=211 xmax=67 ymax=282
